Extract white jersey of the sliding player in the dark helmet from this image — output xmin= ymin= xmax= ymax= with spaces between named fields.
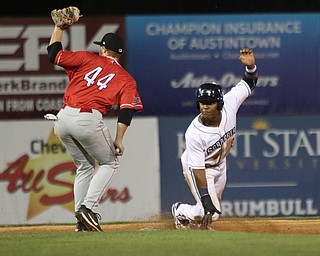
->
xmin=181 ymin=80 xmax=251 ymax=169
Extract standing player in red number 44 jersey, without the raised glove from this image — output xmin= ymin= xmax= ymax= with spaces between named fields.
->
xmin=47 ymin=17 xmax=143 ymax=232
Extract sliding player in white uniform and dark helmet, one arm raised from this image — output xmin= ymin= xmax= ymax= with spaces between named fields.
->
xmin=172 ymin=48 xmax=258 ymax=229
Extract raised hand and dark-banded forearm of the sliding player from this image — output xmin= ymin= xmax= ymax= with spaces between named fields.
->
xmin=239 ymin=48 xmax=258 ymax=91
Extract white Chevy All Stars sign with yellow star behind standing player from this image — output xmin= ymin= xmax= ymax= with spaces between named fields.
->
xmin=0 ymin=117 xmax=160 ymax=225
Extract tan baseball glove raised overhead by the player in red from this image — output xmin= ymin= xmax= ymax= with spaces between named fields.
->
xmin=51 ymin=6 xmax=82 ymax=30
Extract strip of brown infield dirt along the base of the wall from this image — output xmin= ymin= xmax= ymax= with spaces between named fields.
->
xmin=0 ymin=218 xmax=320 ymax=235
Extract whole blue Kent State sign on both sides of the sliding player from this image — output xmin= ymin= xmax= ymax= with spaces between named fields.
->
xmin=159 ymin=116 xmax=320 ymax=216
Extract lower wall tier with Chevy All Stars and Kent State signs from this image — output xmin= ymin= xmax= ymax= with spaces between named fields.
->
xmin=0 ymin=116 xmax=320 ymax=224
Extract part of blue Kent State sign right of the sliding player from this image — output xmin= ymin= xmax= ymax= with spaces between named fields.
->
xmin=224 ymin=116 xmax=320 ymax=216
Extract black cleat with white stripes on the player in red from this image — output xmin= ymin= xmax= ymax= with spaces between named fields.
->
xmin=75 ymin=205 xmax=103 ymax=232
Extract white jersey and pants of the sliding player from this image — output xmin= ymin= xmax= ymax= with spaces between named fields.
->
xmin=176 ymin=80 xmax=251 ymax=220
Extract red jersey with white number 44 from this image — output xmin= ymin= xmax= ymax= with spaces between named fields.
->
xmin=55 ymin=50 xmax=143 ymax=114
